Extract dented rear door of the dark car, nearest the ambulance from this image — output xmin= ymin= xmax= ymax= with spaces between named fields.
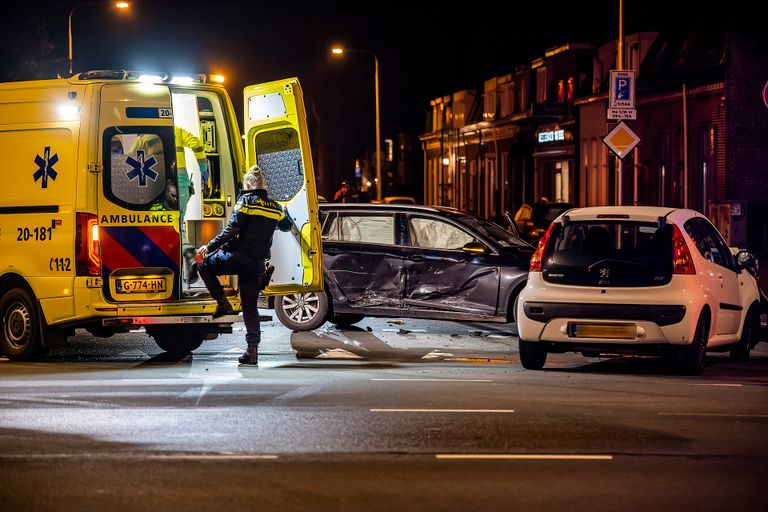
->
xmin=323 ymin=211 xmax=404 ymax=314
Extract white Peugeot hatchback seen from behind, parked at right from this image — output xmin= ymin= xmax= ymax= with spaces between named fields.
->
xmin=516 ymin=206 xmax=760 ymax=375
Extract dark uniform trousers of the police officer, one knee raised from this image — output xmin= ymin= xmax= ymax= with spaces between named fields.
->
xmin=198 ymin=249 xmax=264 ymax=345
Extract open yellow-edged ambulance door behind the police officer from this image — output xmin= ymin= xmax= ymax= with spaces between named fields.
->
xmin=244 ymin=78 xmax=323 ymax=295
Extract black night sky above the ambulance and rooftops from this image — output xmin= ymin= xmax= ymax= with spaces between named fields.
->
xmin=0 ymin=0 xmax=741 ymax=194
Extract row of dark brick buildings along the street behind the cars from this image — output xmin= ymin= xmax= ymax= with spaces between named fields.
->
xmin=420 ymin=23 xmax=768 ymax=259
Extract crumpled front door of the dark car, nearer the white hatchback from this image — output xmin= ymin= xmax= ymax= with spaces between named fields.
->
xmin=403 ymin=215 xmax=499 ymax=319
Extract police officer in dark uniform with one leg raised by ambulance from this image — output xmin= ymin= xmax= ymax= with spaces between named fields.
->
xmin=197 ymin=165 xmax=292 ymax=366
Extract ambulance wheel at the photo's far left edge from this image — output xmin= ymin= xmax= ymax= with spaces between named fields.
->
xmin=0 ymin=288 xmax=45 ymax=361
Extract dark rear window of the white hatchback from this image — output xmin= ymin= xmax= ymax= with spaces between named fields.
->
xmin=542 ymin=220 xmax=672 ymax=287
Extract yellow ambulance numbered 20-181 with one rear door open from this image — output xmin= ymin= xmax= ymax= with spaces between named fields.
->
xmin=0 ymin=70 xmax=323 ymax=360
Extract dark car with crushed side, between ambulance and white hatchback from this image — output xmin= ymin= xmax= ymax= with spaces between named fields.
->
xmin=274 ymin=203 xmax=533 ymax=330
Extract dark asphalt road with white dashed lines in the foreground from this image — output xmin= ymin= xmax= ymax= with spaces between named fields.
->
xmin=0 ymin=314 xmax=768 ymax=512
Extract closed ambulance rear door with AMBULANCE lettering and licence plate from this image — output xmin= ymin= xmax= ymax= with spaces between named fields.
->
xmin=98 ymin=83 xmax=181 ymax=302
